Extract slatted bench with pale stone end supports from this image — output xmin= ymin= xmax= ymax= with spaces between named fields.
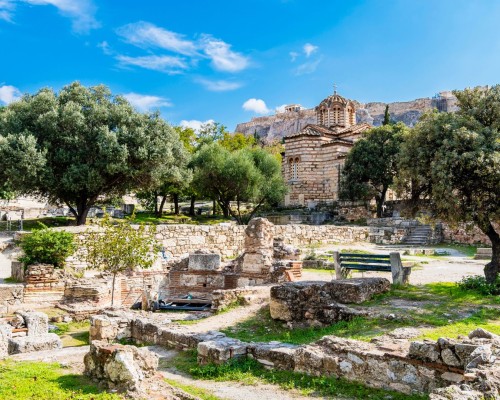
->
xmin=333 ymin=251 xmax=411 ymax=285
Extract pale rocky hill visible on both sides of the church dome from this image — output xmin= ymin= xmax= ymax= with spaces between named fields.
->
xmin=235 ymin=92 xmax=456 ymax=141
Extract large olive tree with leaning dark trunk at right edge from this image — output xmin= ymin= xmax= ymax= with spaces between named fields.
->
xmin=400 ymin=85 xmax=500 ymax=283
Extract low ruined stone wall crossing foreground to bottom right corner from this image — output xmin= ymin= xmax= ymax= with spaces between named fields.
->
xmin=90 ymin=312 xmax=500 ymax=400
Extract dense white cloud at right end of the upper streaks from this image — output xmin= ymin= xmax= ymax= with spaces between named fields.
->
xmin=200 ymin=35 xmax=249 ymax=72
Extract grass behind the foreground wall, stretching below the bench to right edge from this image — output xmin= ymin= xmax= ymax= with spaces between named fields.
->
xmin=223 ymin=283 xmax=500 ymax=344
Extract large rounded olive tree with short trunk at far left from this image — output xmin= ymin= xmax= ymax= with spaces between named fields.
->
xmin=0 ymin=82 xmax=184 ymax=224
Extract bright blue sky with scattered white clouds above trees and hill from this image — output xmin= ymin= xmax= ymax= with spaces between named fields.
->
xmin=0 ymin=0 xmax=500 ymax=130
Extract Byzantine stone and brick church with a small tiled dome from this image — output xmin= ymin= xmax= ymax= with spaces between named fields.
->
xmin=282 ymin=90 xmax=371 ymax=206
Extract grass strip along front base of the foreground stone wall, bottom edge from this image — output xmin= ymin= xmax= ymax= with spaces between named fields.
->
xmin=173 ymin=351 xmax=428 ymax=400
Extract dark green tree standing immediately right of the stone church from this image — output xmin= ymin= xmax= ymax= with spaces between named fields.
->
xmin=340 ymin=123 xmax=408 ymax=217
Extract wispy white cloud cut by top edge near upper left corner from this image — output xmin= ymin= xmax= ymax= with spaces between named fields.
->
xmin=21 ymin=0 xmax=100 ymax=33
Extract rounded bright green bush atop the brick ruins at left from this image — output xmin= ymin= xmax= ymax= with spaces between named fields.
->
xmin=20 ymin=225 xmax=75 ymax=268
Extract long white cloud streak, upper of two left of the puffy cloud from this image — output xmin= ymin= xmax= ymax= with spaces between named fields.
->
xmin=117 ymin=21 xmax=196 ymax=55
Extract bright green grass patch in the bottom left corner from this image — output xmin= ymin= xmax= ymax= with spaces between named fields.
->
xmin=0 ymin=360 xmax=123 ymax=400
